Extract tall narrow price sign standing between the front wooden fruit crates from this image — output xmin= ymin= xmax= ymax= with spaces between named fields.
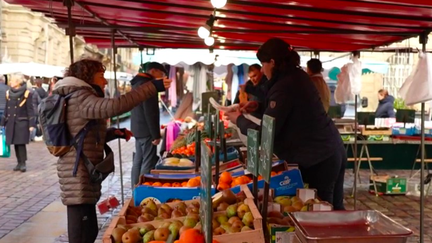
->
xmin=200 ymin=144 xmax=213 ymax=243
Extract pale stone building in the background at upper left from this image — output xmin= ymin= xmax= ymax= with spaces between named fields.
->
xmin=0 ymin=0 xmax=138 ymax=72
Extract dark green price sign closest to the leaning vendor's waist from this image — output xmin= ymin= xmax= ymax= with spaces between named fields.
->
xmin=259 ymin=115 xmax=275 ymax=182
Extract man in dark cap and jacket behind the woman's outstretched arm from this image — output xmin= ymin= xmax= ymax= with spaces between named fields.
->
xmin=131 ymin=62 xmax=167 ymax=188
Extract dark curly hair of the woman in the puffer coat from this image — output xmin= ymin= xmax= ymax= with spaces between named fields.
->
xmin=64 ymin=59 xmax=105 ymax=84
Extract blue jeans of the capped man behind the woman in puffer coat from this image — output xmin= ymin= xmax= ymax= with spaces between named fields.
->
xmin=131 ymin=137 xmax=159 ymax=188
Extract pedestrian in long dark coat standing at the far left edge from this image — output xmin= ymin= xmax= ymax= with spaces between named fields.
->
xmin=0 ymin=74 xmax=36 ymax=172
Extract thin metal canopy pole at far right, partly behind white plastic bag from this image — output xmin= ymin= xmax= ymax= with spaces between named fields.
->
xmin=420 ymin=32 xmax=429 ymax=243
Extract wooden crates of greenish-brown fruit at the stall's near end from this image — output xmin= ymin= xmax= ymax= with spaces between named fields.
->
xmin=108 ymin=190 xmax=263 ymax=243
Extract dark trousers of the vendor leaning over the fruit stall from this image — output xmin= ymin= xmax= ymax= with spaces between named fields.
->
xmin=299 ymin=145 xmax=347 ymax=210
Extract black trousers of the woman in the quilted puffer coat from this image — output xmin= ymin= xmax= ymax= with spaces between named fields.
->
xmin=67 ymin=204 xmax=99 ymax=243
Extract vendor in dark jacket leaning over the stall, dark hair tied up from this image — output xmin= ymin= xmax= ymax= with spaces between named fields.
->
xmin=226 ymin=38 xmax=347 ymax=210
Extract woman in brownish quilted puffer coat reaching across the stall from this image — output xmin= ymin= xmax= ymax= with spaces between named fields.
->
xmin=53 ymin=59 xmax=171 ymax=243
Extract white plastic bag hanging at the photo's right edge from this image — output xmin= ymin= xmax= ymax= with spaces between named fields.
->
xmin=399 ymin=53 xmax=432 ymax=105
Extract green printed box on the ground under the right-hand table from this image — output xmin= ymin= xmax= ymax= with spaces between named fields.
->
xmin=369 ymin=175 xmax=407 ymax=195
